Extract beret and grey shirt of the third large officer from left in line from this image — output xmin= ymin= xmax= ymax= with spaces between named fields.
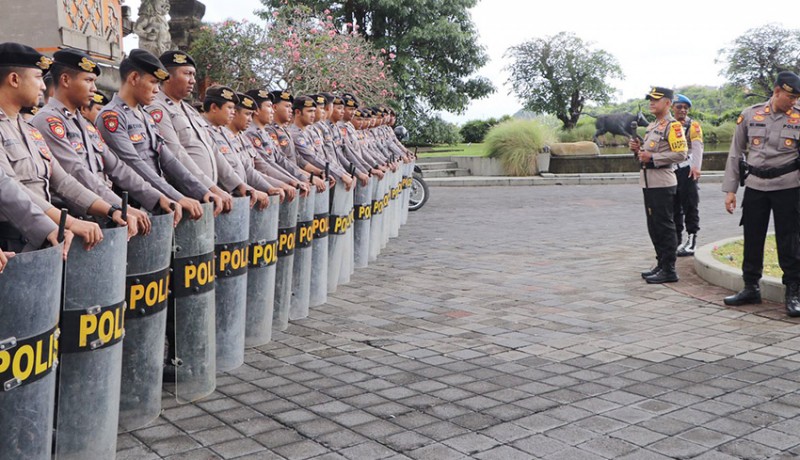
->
xmin=96 ymin=49 xmax=209 ymax=201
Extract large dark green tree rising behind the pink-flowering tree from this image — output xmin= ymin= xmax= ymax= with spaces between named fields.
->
xmin=261 ymin=0 xmax=494 ymax=113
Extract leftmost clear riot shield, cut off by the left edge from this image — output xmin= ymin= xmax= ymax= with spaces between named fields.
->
xmin=0 ymin=246 xmax=63 ymax=460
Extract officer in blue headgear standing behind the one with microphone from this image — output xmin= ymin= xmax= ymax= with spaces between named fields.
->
xmin=672 ymin=94 xmax=703 ymax=257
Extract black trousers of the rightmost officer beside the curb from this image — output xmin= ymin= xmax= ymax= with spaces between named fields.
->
xmin=741 ymin=188 xmax=800 ymax=284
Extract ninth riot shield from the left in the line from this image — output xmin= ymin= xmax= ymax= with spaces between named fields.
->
xmin=309 ymin=184 xmax=330 ymax=307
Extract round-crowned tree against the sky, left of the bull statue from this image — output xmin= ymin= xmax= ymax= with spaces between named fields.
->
xmin=505 ymin=32 xmax=622 ymax=129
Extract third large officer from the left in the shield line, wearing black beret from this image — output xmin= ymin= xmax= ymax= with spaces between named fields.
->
xmin=95 ymin=49 xmax=222 ymax=219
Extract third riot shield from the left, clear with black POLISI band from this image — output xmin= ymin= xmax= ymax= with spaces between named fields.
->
xmin=119 ymin=213 xmax=174 ymax=432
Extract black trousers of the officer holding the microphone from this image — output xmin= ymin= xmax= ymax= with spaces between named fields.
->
xmin=642 ymin=187 xmax=678 ymax=267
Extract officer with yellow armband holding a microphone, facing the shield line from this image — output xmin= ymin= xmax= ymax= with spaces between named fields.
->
xmin=628 ymin=86 xmax=688 ymax=284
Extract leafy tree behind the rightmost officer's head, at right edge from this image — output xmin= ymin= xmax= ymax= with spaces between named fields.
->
xmin=717 ymin=24 xmax=800 ymax=95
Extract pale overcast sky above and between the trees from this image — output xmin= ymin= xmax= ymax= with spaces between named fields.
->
xmin=125 ymin=0 xmax=792 ymax=123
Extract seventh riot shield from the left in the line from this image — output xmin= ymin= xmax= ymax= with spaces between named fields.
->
xmin=272 ymin=198 xmax=300 ymax=331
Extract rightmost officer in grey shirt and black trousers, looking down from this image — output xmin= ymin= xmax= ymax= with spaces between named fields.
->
xmin=722 ymin=72 xmax=800 ymax=316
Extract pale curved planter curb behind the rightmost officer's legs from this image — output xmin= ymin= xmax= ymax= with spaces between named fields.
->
xmin=694 ymin=237 xmax=784 ymax=304
